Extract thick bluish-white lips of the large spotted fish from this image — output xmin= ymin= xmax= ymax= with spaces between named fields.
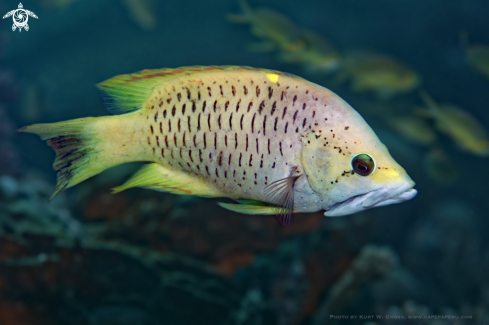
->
xmin=324 ymin=181 xmax=418 ymax=217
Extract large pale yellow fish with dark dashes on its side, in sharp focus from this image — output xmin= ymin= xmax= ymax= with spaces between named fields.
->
xmin=20 ymin=67 xmax=416 ymax=226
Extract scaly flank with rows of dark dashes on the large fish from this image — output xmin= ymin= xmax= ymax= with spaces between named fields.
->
xmin=139 ymin=71 xmax=317 ymax=199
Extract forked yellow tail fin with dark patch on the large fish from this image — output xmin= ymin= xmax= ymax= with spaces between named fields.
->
xmin=19 ymin=118 xmax=113 ymax=201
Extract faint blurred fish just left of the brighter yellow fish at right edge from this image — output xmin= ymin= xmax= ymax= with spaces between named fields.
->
xmin=387 ymin=116 xmax=436 ymax=146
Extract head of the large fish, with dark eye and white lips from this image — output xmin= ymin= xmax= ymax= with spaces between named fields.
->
xmin=301 ymin=97 xmax=417 ymax=217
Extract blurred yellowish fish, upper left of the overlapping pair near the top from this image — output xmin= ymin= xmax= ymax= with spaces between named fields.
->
xmin=226 ymin=0 xmax=305 ymax=51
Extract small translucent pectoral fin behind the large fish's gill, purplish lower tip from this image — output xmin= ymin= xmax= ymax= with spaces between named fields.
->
xmin=263 ymin=168 xmax=301 ymax=227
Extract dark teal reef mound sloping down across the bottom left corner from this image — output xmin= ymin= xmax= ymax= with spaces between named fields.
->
xmin=0 ymin=237 xmax=275 ymax=325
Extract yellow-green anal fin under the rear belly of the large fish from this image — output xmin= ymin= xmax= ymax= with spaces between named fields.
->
xmin=111 ymin=163 xmax=226 ymax=197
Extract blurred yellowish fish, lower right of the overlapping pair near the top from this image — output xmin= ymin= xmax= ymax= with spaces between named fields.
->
xmin=280 ymin=30 xmax=341 ymax=74
